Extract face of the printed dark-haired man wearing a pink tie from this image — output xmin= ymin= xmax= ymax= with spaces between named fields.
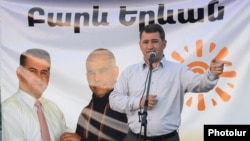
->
xmin=17 ymin=55 xmax=50 ymax=99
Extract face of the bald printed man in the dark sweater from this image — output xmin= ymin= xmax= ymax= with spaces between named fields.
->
xmin=86 ymin=54 xmax=119 ymax=97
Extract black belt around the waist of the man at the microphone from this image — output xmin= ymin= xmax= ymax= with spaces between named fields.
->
xmin=129 ymin=129 xmax=178 ymax=140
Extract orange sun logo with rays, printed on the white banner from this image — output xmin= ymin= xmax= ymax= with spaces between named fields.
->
xmin=171 ymin=40 xmax=236 ymax=111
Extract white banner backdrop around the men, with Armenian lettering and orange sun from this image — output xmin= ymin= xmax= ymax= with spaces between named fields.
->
xmin=0 ymin=0 xmax=250 ymax=141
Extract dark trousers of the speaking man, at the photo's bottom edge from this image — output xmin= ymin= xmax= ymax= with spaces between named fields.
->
xmin=123 ymin=131 xmax=180 ymax=141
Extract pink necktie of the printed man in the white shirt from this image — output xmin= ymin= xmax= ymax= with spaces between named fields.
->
xmin=35 ymin=100 xmax=50 ymax=141
